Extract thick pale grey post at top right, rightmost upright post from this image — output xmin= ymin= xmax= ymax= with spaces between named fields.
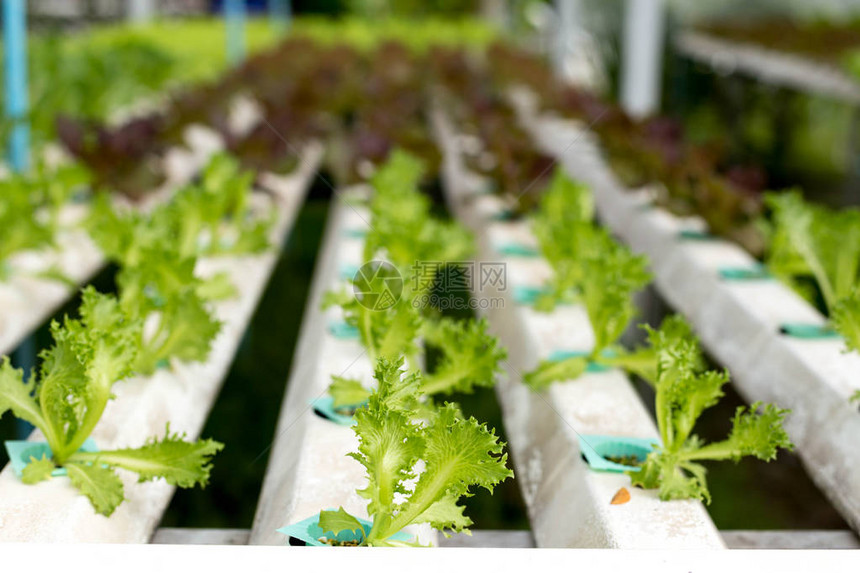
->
xmin=621 ymin=0 xmax=666 ymax=117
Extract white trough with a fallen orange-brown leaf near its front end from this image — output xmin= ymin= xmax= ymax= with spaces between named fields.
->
xmin=434 ymin=108 xmax=724 ymax=549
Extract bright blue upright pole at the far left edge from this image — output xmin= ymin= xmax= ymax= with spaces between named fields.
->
xmin=3 ymin=0 xmax=30 ymax=172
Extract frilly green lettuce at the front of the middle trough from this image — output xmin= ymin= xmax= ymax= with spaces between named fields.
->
xmin=319 ymin=359 xmax=513 ymax=547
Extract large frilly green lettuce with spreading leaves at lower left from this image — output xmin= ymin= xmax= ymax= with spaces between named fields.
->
xmin=0 ymin=288 xmax=223 ymax=516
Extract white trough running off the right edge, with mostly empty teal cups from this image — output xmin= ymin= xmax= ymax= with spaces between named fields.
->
xmin=510 ymin=95 xmax=860 ymax=531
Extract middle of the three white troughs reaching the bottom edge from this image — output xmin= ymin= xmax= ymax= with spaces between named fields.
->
xmin=249 ymin=189 xmax=436 ymax=545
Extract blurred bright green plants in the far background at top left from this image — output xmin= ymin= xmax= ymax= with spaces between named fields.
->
xmin=0 ymin=18 xmax=495 ymax=147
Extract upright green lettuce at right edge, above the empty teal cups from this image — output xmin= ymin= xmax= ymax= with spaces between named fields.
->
xmin=765 ymin=191 xmax=860 ymax=313
